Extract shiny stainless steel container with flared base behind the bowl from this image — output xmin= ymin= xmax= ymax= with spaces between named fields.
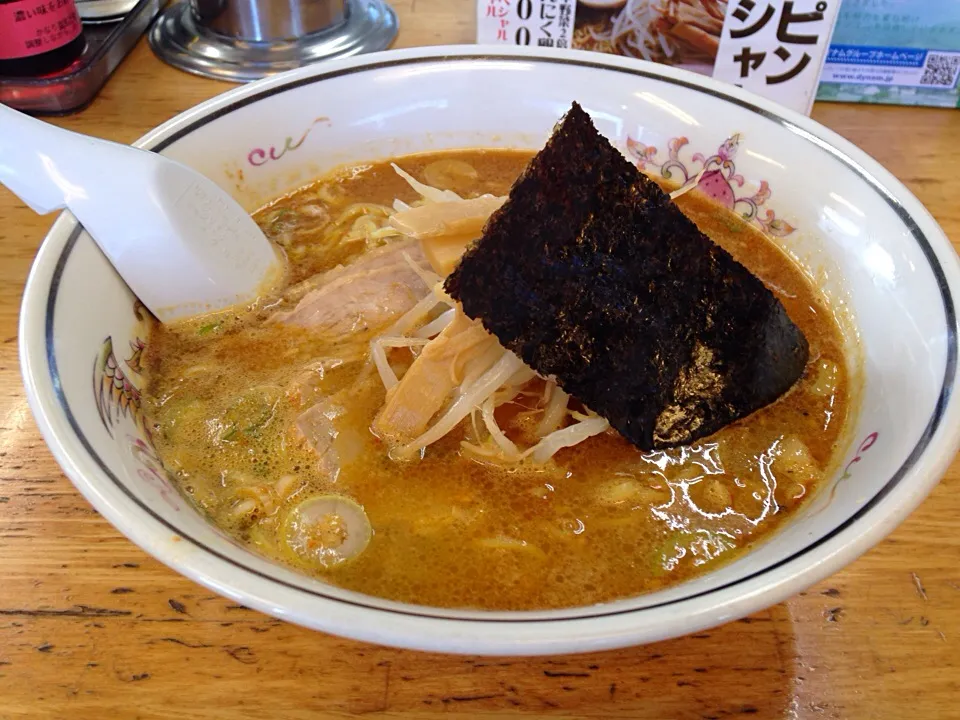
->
xmin=149 ymin=0 xmax=397 ymax=82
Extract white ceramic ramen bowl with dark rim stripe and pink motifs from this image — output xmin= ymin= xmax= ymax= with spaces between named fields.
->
xmin=20 ymin=47 xmax=960 ymax=654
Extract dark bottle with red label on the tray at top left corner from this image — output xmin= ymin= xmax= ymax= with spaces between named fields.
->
xmin=0 ymin=0 xmax=86 ymax=76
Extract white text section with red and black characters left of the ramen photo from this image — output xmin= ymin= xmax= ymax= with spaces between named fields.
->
xmin=477 ymin=0 xmax=576 ymax=48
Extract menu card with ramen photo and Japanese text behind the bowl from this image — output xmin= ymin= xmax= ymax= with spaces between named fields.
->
xmin=477 ymin=0 xmax=840 ymax=113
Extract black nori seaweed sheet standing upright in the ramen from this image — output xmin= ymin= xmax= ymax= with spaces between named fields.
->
xmin=445 ymin=103 xmax=808 ymax=450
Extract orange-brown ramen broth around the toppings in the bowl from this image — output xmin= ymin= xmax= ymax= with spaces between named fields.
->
xmin=144 ymin=150 xmax=851 ymax=610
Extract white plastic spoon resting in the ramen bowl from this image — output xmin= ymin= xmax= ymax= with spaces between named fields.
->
xmin=0 ymin=105 xmax=283 ymax=322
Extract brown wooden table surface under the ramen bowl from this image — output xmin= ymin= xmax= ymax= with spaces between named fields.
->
xmin=0 ymin=0 xmax=960 ymax=720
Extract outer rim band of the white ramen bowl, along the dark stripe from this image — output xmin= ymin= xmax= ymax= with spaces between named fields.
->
xmin=20 ymin=45 xmax=960 ymax=654
